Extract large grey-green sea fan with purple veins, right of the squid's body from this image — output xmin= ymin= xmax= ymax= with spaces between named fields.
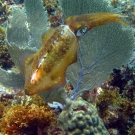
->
xmin=61 ymin=0 xmax=134 ymax=98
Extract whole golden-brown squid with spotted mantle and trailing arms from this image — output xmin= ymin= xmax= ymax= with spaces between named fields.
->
xmin=22 ymin=13 xmax=127 ymax=95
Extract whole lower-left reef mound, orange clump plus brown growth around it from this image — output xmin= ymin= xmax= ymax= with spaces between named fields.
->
xmin=0 ymin=95 xmax=65 ymax=135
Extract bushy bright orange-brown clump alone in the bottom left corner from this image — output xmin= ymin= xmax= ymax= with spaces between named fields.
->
xmin=0 ymin=104 xmax=56 ymax=135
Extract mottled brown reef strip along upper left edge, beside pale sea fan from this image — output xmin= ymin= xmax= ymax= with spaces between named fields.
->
xmin=0 ymin=0 xmax=14 ymax=70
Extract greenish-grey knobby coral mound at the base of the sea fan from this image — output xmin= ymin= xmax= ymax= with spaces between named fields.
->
xmin=58 ymin=98 xmax=109 ymax=135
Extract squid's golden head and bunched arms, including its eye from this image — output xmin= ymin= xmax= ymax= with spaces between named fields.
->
xmin=65 ymin=12 xmax=128 ymax=36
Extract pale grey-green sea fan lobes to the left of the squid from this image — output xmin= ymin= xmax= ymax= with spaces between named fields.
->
xmin=0 ymin=0 xmax=47 ymax=88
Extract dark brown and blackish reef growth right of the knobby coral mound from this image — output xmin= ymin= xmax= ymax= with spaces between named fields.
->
xmin=83 ymin=66 xmax=135 ymax=135
